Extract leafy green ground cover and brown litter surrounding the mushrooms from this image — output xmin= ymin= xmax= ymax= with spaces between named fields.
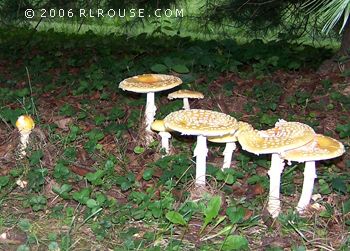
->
xmin=0 ymin=22 xmax=350 ymax=250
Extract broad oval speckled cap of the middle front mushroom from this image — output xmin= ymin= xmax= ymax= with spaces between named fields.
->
xmin=164 ymin=109 xmax=238 ymax=136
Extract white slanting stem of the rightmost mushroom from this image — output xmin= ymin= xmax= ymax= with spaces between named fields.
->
xmin=296 ymin=161 xmax=317 ymax=213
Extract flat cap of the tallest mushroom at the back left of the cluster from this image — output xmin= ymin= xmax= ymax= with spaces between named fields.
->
xmin=119 ymin=74 xmax=182 ymax=93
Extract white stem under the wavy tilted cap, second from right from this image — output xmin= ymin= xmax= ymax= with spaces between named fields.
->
xmin=267 ymin=153 xmax=284 ymax=218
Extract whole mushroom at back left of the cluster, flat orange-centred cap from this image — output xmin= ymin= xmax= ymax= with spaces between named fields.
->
xmin=119 ymin=74 xmax=182 ymax=145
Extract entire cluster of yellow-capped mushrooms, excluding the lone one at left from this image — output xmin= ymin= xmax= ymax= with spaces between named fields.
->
xmin=119 ymin=74 xmax=345 ymax=218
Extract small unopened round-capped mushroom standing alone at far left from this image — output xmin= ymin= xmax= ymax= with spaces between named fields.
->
xmin=16 ymin=115 xmax=35 ymax=159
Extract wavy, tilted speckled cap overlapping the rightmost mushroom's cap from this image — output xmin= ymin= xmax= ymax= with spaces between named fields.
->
xmin=237 ymin=120 xmax=315 ymax=154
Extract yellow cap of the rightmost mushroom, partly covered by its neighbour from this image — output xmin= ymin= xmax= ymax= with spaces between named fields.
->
xmin=282 ymin=134 xmax=345 ymax=162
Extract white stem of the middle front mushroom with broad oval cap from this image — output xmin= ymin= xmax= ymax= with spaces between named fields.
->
xmin=194 ymin=135 xmax=208 ymax=186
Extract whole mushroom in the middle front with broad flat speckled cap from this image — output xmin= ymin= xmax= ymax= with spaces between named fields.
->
xmin=164 ymin=109 xmax=238 ymax=186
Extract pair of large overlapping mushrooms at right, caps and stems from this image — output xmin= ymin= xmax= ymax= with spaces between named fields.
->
xmin=238 ymin=120 xmax=344 ymax=218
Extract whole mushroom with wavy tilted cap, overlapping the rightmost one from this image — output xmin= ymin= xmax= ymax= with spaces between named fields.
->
xmin=237 ymin=120 xmax=315 ymax=218
